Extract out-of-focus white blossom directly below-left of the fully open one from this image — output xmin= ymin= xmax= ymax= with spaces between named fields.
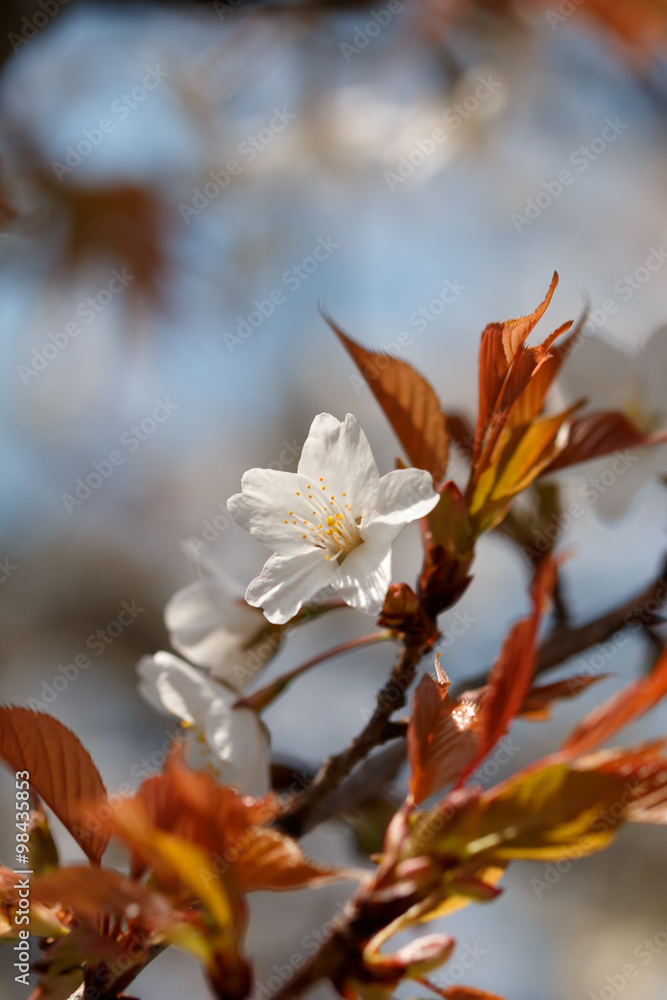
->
xmin=164 ymin=549 xmax=282 ymax=691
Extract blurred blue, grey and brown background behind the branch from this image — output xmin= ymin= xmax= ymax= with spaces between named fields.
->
xmin=0 ymin=0 xmax=667 ymax=1000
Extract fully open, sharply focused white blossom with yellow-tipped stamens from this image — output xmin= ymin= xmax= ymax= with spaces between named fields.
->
xmin=227 ymin=413 xmax=438 ymax=624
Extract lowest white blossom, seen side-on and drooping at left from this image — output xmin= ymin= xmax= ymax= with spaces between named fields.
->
xmin=137 ymin=652 xmax=269 ymax=795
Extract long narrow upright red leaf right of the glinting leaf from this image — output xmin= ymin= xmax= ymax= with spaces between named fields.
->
xmin=461 ymin=557 xmax=557 ymax=781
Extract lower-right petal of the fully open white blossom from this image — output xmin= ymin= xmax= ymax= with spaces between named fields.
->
xmin=333 ymin=526 xmax=394 ymax=615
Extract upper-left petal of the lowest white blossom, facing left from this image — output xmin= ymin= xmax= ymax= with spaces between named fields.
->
xmin=137 ymin=651 xmax=215 ymax=725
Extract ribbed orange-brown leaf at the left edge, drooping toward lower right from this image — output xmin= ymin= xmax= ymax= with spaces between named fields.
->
xmin=0 ymin=706 xmax=109 ymax=863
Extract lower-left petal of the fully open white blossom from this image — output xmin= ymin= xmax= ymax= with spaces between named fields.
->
xmin=246 ymin=546 xmax=336 ymax=625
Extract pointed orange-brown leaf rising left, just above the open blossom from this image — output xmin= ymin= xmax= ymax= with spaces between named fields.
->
xmin=324 ymin=316 xmax=449 ymax=485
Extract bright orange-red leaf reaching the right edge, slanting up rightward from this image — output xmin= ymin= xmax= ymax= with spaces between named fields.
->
xmin=563 ymin=650 xmax=667 ymax=757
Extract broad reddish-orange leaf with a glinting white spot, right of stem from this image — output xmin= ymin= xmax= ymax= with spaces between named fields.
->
xmin=407 ymin=674 xmax=477 ymax=804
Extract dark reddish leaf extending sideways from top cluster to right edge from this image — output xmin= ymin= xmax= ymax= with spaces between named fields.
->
xmin=541 ymin=410 xmax=666 ymax=475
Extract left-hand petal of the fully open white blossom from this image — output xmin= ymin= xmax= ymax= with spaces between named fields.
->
xmin=227 ymin=469 xmax=312 ymax=556
